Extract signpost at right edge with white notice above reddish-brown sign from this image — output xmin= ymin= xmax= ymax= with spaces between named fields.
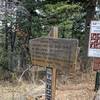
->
xmin=88 ymin=21 xmax=100 ymax=91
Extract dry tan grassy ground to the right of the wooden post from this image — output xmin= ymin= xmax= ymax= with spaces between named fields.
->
xmin=56 ymin=72 xmax=95 ymax=100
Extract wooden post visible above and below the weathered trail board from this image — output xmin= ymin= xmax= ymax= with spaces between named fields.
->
xmin=45 ymin=26 xmax=58 ymax=100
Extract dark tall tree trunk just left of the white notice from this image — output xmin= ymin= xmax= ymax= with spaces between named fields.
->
xmin=82 ymin=0 xmax=97 ymax=71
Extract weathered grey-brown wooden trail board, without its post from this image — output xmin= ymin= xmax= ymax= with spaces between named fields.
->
xmin=30 ymin=38 xmax=78 ymax=71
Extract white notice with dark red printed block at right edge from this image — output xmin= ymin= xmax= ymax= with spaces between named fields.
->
xmin=88 ymin=21 xmax=100 ymax=57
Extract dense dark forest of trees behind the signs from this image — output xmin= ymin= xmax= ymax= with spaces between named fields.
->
xmin=0 ymin=0 xmax=100 ymax=79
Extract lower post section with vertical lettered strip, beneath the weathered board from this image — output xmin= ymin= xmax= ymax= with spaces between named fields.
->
xmin=45 ymin=67 xmax=56 ymax=100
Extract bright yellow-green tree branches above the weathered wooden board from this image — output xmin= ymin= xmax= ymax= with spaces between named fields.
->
xmin=44 ymin=2 xmax=82 ymax=38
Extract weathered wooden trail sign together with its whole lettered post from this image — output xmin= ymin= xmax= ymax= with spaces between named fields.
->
xmin=30 ymin=27 xmax=78 ymax=100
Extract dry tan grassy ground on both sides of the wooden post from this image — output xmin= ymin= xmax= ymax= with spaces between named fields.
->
xmin=0 ymin=72 xmax=95 ymax=100
